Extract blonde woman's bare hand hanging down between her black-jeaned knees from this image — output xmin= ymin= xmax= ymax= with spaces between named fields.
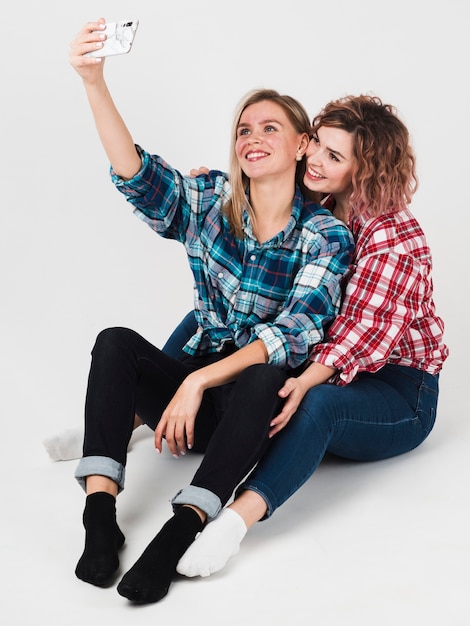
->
xmin=155 ymin=375 xmax=203 ymax=457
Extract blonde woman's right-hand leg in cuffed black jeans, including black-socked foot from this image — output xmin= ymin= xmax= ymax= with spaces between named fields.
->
xmin=134 ymin=365 xmax=285 ymax=602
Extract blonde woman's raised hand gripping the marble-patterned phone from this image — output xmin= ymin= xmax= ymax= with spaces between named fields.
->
xmin=69 ymin=18 xmax=106 ymax=82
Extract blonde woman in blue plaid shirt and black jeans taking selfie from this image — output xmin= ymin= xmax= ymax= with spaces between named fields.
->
xmin=70 ymin=19 xmax=353 ymax=603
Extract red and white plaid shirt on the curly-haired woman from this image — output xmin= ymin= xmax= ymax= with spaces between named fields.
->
xmin=310 ymin=202 xmax=448 ymax=385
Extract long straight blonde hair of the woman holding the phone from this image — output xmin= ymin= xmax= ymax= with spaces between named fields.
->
xmin=224 ymin=89 xmax=318 ymax=239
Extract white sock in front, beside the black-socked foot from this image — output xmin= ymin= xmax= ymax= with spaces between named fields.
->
xmin=176 ymin=509 xmax=248 ymax=577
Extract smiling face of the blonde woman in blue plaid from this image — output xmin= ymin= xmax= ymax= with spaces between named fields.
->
xmin=235 ymin=100 xmax=307 ymax=181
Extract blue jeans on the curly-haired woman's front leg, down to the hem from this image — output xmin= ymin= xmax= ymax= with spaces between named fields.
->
xmin=237 ymin=365 xmax=438 ymax=519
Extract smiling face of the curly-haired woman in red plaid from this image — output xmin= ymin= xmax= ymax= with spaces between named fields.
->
xmin=304 ymin=126 xmax=356 ymax=198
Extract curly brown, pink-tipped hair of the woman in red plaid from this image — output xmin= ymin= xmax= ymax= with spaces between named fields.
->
xmin=313 ymin=95 xmax=418 ymax=216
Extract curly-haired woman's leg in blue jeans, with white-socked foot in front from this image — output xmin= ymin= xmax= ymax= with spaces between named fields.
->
xmin=178 ymin=365 xmax=438 ymax=576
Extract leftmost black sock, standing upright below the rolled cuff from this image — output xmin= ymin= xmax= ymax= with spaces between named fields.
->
xmin=75 ymin=492 xmax=125 ymax=587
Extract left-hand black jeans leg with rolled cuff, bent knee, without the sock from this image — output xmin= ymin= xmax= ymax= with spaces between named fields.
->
xmin=76 ymin=328 xmax=188 ymax=489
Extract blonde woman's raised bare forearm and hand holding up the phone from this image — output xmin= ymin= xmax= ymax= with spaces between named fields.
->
xmin=69 ymin=18 xmax=141 ymax=179
